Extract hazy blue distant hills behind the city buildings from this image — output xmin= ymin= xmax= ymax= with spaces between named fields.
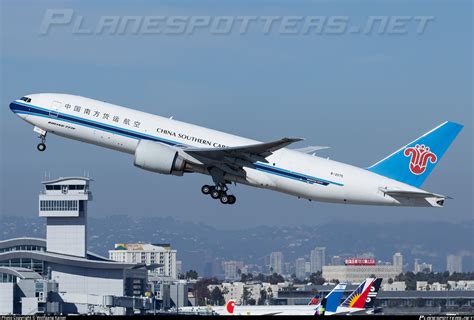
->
xmin=0 ymin=215 xmax=474 ymax=272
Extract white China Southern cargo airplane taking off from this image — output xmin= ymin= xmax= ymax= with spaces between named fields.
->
xmin=10 ymin=93 xmax=463 ymax=207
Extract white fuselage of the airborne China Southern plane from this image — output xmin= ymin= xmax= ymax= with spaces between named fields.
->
xmin=10 ymin=94 xmax=436 ymax=206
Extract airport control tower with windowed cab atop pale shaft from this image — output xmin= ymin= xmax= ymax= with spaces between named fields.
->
xmin=39 ymin=177 xmax=92 ymax=257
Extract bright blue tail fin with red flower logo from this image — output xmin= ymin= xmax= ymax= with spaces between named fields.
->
xmin=368 ymin=121 xmax=463 ymax=188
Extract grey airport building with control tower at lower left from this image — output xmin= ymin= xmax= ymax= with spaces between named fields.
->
xmin=0 ymin=177 xmax=147 ymax=315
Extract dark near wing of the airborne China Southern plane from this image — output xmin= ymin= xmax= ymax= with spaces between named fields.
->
xmin=183 ymin=138 xmax=303 ymax=176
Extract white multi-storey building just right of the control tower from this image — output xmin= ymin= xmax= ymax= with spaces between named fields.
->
xmin=109 ymin=243 xmax=177 ymax=279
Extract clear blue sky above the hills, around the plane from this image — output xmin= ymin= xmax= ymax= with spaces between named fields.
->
xmin=0 ymin=0 xmax=473 ymax=228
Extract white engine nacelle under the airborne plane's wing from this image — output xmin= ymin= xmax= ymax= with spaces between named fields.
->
xmin=133 ymin=140 xmax=185 ymax=176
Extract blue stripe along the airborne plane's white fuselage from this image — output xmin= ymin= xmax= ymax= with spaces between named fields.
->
xmin=10 ymin=101 xmax=343 ymax=186
